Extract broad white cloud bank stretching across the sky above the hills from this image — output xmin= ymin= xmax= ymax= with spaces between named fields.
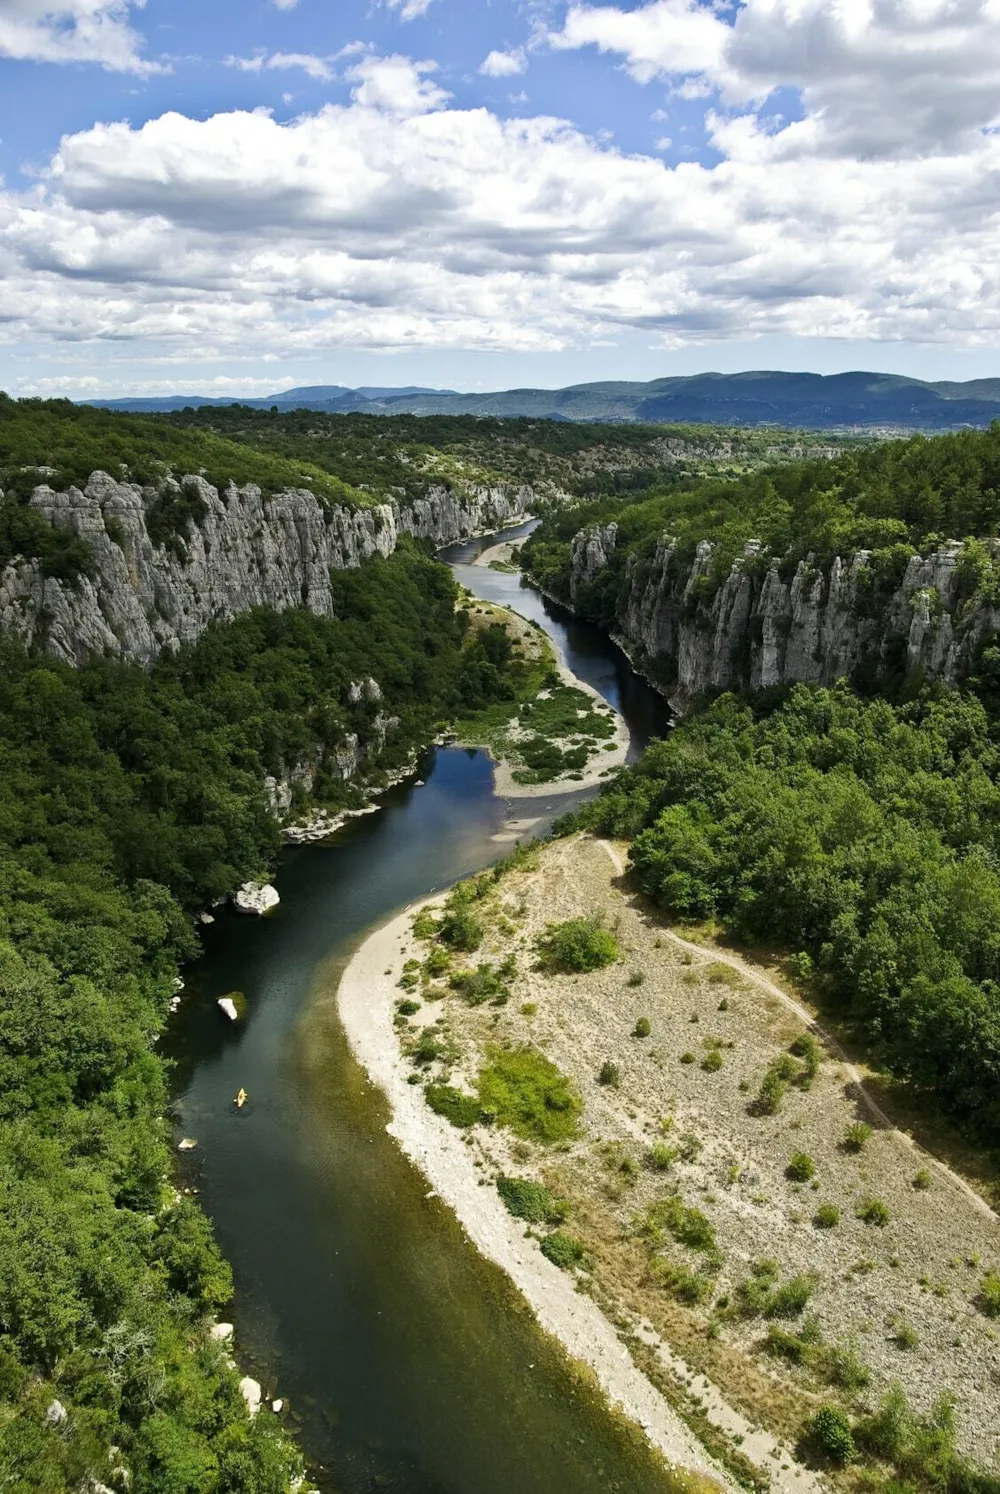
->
xmin=0 ymin=45 xmax=1000 ymax=366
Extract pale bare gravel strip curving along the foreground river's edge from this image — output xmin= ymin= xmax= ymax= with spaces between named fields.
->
xmin=338 ymin=899 xmax=732 ymax=1488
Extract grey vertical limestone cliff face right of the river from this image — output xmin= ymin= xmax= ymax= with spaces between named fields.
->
xmin=571 ymin=524 xmax=1000 ymax=708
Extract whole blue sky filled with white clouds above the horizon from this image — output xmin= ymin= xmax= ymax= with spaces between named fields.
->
xmin=0 ymin=0 xmax=1000 ymax=399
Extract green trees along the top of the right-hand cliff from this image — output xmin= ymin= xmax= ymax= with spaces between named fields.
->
xmin=523 ymin=423 xmax=1000 ymax=624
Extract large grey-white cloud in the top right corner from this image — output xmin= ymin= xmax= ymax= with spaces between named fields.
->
xmin=550 ymin=0 xmax=1000 ymax=157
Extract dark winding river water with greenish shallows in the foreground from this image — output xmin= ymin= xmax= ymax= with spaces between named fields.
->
xmin=164 ymin=526 xmax=667 ymax=1494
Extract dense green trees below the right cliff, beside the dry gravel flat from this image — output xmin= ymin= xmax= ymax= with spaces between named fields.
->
xmin=568 ymin=686 xmax=1000 ymax=1143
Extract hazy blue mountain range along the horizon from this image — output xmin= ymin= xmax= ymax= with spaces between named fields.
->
xmin=84 ymin=372 xmax=1000 ymax=430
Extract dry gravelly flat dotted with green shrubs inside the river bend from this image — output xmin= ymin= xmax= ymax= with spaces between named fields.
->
xmin=386 ymin=837 xmax=1000 ymax=1488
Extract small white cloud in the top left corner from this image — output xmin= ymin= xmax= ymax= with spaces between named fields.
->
xmin=0 ymin=0 xmax=161 ymax=73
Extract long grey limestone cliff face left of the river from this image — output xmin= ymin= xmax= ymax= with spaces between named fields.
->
xmin=0 ymin=472 xmax=534 ymax=663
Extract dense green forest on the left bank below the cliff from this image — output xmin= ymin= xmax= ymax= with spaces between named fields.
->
xmin=0 ymin=544 xmax=519 ymax=1494
